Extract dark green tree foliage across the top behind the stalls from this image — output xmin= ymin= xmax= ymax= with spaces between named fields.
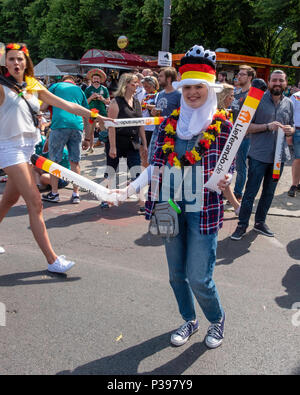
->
xmin=0 ymin=0 xmax=300 ymax=72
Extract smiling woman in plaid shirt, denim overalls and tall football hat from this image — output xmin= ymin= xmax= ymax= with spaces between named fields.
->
xmin=113 ymin=46 xmax=232 ymax=348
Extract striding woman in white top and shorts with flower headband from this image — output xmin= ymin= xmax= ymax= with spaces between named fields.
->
xmin=0 ymin=44 xmax=112 ymax=273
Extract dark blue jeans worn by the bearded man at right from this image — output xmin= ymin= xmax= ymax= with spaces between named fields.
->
xmin=238 ymin=158 xmax=284 ymax=228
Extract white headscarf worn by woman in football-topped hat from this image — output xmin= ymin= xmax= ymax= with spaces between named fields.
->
xmin=176 ymin=86 xmax=217 ymax=140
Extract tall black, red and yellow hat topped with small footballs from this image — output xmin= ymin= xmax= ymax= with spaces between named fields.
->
xmin=173 ymin=45 xmax=223 ymax=92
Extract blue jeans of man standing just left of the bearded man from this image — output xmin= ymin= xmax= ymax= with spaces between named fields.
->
xmin=234 ymin=137 xmax=250 ymax=198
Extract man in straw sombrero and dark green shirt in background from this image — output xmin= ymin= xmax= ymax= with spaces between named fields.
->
xmin=84 ymin=69 xmax=110 ymax=152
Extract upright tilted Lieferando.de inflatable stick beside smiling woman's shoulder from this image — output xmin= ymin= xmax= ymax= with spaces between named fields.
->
xmin=204 ymin=78 xmax=267 ymax=193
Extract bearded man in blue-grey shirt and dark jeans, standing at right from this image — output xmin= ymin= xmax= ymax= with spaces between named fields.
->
xmin=231 ymin=70 xmax=295 ymax=240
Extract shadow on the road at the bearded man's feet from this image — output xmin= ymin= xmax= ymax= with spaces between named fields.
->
xmin=216 ymin=230 xmax=257 ymax=265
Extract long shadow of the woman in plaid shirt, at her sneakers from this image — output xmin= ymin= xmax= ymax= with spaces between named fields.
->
xmin=57 ymin=332 xmax=207 ymax=375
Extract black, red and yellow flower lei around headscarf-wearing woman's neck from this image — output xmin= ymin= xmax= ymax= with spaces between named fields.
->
xmin=162 ymin=108 xmax=229 ymax=169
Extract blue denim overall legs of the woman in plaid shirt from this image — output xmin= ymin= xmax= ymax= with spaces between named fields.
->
xmin=165 ymin=209 xmax=224 ymax=323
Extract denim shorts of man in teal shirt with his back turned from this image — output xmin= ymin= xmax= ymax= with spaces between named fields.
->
xmin=49 ymin=129 xmax=82 ymax=163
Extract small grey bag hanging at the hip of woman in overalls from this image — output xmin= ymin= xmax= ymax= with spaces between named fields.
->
xmin=149 ymin=199 xmax=181 ymax=239
